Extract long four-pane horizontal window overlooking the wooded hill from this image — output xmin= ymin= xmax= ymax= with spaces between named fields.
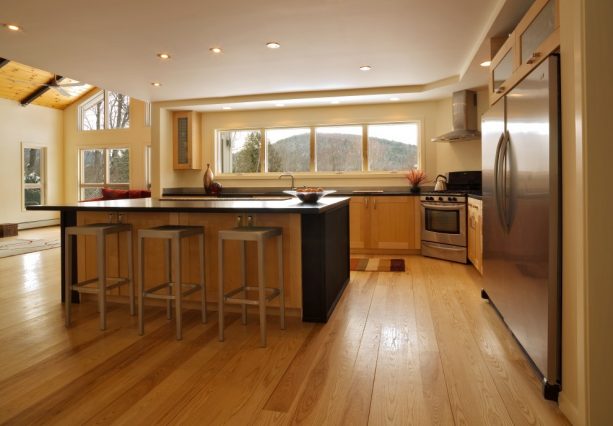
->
xmin=217 ymin=122 xmax=420 ymax=173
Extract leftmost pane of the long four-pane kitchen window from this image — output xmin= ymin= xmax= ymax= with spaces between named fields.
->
xmin=219 ymin=130 xmax=262 ymax=173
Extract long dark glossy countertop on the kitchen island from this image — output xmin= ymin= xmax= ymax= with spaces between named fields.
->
xmin=27 ymin=196 xmax=349 ymax=214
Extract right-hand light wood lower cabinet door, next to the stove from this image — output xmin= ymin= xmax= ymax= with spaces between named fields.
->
xmin=370 ymin=196 xmax=416 ymax=250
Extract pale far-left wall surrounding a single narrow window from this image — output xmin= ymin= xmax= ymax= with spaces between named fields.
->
xmin=0 ymin=99 xmax=64 ymax=224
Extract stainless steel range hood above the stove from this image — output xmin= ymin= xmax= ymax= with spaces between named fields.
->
xmin=432 ymin=90 xmax=481 ymax=142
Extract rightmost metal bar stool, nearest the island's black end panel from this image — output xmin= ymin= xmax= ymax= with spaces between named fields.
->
xmin=219 ymin=226 xmax=285 ymax=347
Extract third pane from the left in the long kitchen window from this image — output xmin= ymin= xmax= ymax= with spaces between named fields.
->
xmin=315 ymin=126 xmax=362 ymax=172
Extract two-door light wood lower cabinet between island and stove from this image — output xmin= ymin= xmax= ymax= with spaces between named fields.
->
xmin=349 ymin=196 xmax=421 ymax=254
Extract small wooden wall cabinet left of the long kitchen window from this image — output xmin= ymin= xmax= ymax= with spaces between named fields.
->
xmin=172 ymin=111 xmax=202 ymax=170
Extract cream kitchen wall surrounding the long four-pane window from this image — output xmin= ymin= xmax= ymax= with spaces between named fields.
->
xmin=153 ymin=91 xmax=487 ymax=193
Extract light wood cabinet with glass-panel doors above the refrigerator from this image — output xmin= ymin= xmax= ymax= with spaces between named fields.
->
xmin=489 ymin=0 xmax=560 ymax=105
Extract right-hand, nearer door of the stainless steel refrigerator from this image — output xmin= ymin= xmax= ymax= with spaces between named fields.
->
xmin=502 ymin=57 xmax=558 ymax=382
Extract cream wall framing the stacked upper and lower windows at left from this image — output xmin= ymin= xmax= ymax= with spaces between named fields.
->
xmin=63 ymin=98 xmax=151 ymax=203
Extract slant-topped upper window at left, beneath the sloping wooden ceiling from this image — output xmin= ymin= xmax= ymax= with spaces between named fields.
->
xmin=79 ymin=90 xmax=130 ymax=131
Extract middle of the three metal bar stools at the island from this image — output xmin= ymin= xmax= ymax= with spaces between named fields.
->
xmin=138 ymin=225 xmax=206 ymax=340
